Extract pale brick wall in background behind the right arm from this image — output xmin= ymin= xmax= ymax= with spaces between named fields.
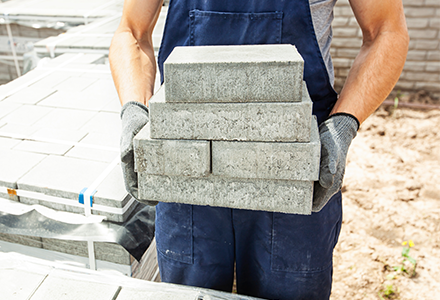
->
xmin=331 ymin=0 xmax=440 ymax=99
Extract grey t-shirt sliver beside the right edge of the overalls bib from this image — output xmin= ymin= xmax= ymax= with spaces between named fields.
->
xmin=309 ymin=0 xmax=337 ymax=85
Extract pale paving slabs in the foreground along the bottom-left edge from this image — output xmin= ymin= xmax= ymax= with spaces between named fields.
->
xmin=0 ymin=253 xmax=258 ymax=300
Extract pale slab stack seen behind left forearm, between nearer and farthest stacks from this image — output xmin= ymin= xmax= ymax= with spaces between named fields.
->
xmin=34 ymin=7 xmax=168 ymax=56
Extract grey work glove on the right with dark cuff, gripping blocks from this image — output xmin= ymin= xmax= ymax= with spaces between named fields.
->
xmin=312 ymin=113 xmax=359 ymax=212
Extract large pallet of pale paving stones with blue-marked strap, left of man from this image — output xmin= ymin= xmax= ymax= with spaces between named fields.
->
xmin=0 ymin=53 xmax=137 ymax=222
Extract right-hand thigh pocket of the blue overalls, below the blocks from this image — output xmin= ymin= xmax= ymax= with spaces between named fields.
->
xmin=271 ymin=193 xmax=342 ymax=273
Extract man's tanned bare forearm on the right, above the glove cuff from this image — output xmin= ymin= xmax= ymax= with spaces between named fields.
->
xmin=332 ymin=32 xmax=408 ymax=123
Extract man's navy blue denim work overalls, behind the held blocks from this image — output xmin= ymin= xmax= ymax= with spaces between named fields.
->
xmin=156 ymin=0 xmax=342 ymax=300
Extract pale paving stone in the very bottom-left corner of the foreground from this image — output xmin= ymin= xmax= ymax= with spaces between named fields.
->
xmin=0 ymin=268 xmax=46 ymax=300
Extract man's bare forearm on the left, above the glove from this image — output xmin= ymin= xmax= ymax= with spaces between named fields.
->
xmin=109 ymin=0 xmax=162 ymax=106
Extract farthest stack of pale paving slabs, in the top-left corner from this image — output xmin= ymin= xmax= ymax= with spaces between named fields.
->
xmin=0 ymin=0 xmax=123 ymax=83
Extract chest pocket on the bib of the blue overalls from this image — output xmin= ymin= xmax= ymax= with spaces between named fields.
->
xmin=189 ymin=10 xmax=283 ymax=46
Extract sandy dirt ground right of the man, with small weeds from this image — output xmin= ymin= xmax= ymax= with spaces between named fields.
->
xmin=331 ymin=99 xmax=440 ymax=300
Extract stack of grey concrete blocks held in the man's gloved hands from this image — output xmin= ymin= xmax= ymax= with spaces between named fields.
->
xmin=134 ymin=45 xmax=320 ymax=214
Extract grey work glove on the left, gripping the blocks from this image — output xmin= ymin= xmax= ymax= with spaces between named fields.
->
xmin=121 ymin=101 xmax=158 ymax=205
